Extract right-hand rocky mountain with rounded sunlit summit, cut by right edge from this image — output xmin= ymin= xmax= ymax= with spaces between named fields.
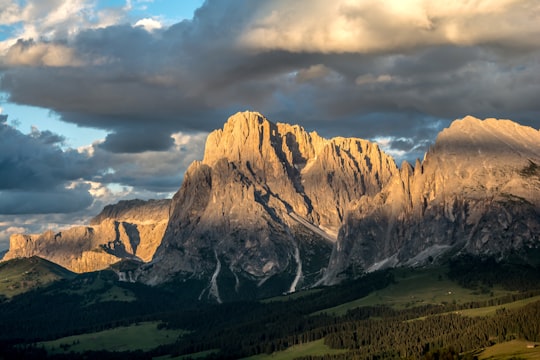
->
xmin=325 ymin=116 xmax=540 ymax=283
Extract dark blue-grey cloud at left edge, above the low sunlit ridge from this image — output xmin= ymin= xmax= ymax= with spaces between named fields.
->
xmin=0 ymin=121 xmax=95 ymax=214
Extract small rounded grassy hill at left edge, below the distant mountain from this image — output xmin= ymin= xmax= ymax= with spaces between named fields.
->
xmin=0 ymin=257 xmax=76 ymax=298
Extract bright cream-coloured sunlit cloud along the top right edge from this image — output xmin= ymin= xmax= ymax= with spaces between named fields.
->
xmin=239 ymin=0 xmax=540 ymax=53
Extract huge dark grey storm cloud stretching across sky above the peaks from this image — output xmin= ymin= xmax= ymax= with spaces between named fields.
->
xmin=0 ymin=0 xmax=540 ymax=153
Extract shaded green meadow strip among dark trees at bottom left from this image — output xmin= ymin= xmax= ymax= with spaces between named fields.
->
xmin=41 ymin=322 xmax=186 ymax=353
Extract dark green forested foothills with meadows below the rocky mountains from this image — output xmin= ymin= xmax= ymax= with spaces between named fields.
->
xmin=0 ymin=257 xmax=540 ymax=359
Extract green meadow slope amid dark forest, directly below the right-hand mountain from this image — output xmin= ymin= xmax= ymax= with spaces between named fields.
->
xmin=310 ymin=268 xmax=510 ymax=316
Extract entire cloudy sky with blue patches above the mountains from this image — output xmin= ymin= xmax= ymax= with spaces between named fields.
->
xmin=0 ymin=0 xmax=540 ymax=250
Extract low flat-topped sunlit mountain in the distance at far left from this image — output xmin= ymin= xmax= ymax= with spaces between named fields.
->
xmin=3 ymin=200 xmax=170 ymax=273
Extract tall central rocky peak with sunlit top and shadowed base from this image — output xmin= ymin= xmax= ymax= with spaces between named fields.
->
xmin=139 ymin=112 xmax=398 ymax=301
